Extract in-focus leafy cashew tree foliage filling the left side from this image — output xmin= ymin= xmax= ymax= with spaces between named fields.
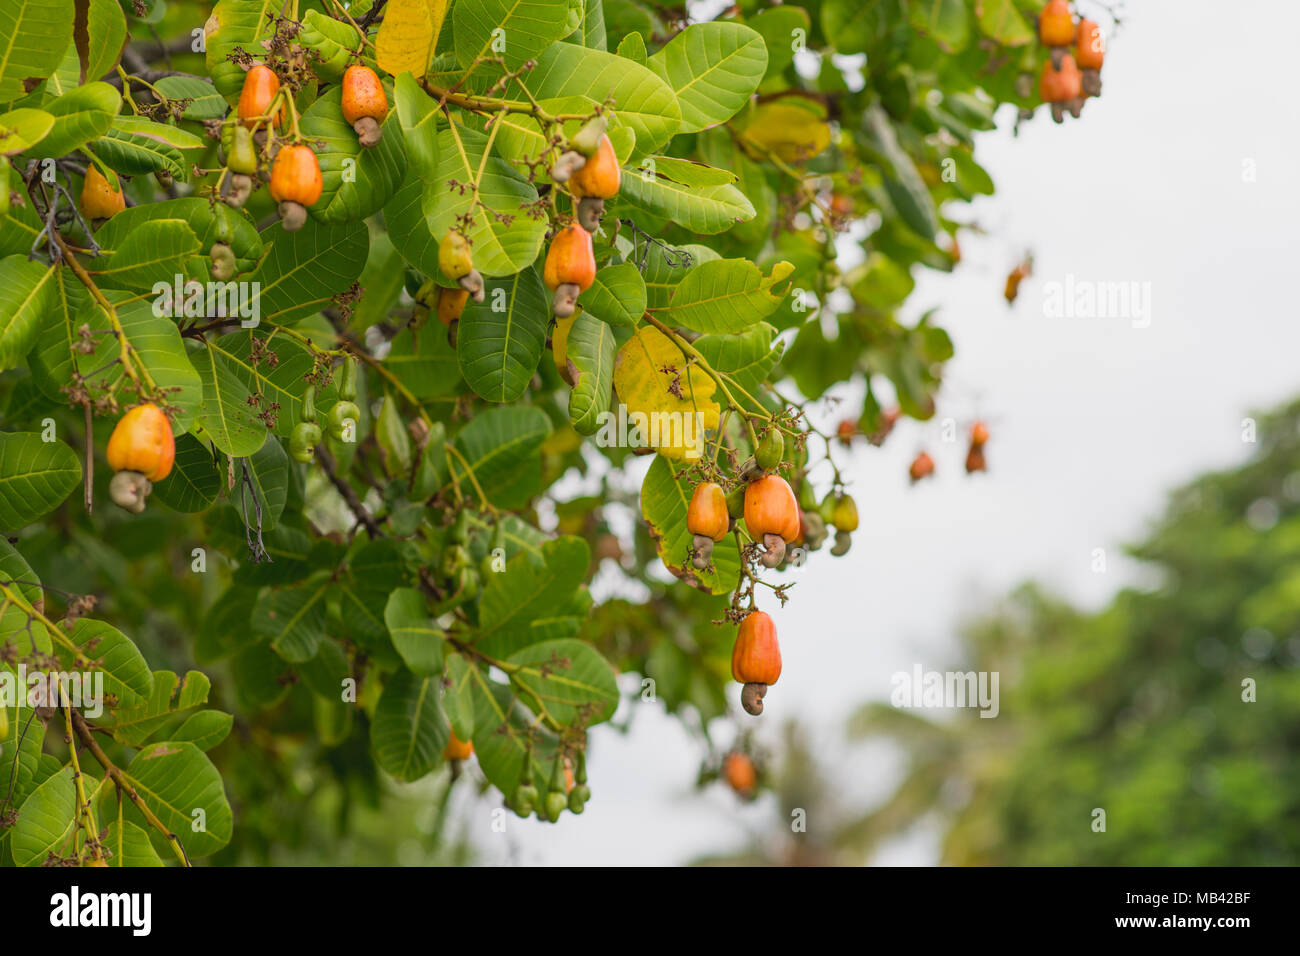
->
xmin=0 ymin=0 xmax=1086 ymax=864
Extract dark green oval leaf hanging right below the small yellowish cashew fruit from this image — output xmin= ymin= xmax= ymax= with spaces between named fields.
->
xmin=457 ymin=268 xmax=550 ymax=403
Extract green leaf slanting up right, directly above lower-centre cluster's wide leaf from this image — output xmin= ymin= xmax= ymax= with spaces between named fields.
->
xmin=473 ymin=535 xmax=592 ymax=658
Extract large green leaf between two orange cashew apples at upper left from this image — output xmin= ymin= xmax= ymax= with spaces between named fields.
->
xmin=300 ymin=87 xmax=407 ymax=222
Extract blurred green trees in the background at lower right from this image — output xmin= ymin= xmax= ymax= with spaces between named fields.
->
xmin=701 ymin=401 xmax=1300 ymax=866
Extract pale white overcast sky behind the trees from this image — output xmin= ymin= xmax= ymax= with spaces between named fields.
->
xmin=465 ymin=0 xmax=1300 ymax=865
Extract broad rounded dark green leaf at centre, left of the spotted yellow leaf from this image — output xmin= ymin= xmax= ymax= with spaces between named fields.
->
xmin=447 ymin=407 xmax=551 ymax=509
